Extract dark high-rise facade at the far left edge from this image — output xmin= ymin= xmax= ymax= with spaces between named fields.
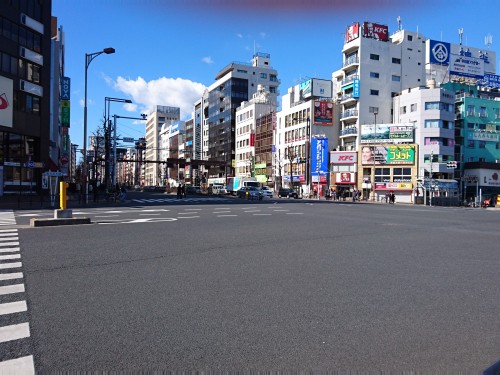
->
xmin=0 ymin=0 xmax=53 ymax=195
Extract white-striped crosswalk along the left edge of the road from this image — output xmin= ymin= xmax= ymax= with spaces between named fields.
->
xmin=0 ymin=217 xmax=35 ymax=374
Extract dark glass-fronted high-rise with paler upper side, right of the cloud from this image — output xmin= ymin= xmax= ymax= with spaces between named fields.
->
xmin=205 ymin=53 xmax=280 ymax=178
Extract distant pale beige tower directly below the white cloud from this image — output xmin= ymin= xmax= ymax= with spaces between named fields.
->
xmin=144 ymin=105 xmax=181 ymax=185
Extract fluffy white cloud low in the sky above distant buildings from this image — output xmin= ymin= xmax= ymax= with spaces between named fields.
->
xmin=114 ymin=76 xmax=206 ymax=119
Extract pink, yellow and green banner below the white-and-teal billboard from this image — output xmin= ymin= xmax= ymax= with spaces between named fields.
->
xmin=361 ymin=145 xmax=415 ymax=165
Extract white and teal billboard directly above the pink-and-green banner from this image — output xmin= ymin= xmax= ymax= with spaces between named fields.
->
xmin=360 ymin=124 xmax=413 ymax=143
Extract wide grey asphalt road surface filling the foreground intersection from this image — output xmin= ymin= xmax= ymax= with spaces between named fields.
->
xmin=0 ymin=199 xmax=500 ymax=373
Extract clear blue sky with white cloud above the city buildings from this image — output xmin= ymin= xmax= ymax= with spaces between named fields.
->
xmin=52 ymin=0 xmax=500 ymax=148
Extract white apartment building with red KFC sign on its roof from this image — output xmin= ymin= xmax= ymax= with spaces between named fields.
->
xmin=332 ymin=22 xmax=426 ymax=151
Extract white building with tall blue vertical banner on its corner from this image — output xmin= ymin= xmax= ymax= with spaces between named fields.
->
xmin=273 ymin=78 xmax=339 ymax=195
